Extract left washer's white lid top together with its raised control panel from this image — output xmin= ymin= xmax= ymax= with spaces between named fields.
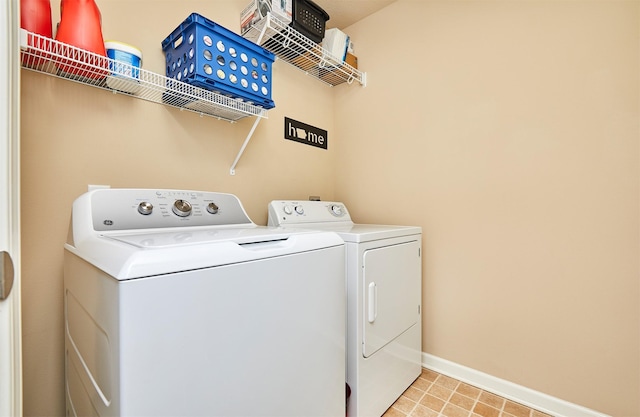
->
xmin=65 ymin=189 xmax=344 ymax=280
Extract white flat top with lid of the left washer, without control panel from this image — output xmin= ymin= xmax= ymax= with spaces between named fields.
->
xmin=65 ymin=226 xmax=344 ymax=281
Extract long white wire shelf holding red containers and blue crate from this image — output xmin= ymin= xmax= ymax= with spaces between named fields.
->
xmin=20 ymin=29 xmax=267 ymax=122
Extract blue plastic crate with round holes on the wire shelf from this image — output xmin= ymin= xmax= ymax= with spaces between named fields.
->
xmin=162 ymin=13 xmax=275 ymax=109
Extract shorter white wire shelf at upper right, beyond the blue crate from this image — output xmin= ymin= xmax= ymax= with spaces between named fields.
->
xmin=242 ymin=12 xmax=367 ymax=86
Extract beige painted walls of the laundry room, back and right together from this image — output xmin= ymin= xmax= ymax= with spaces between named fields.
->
xmin=21 ymin=0 xmax=640 ymax=416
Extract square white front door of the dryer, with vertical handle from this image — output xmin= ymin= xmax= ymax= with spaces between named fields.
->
xmin=362 ymin=241 xmax=421 ymax=358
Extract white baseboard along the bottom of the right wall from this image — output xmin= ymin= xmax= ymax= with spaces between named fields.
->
xmin=422 ymin=352 xmax=610 ymax=417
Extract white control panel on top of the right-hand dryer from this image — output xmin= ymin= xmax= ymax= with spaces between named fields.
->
xmin=268 ymin=200 xmax=351 ymax=226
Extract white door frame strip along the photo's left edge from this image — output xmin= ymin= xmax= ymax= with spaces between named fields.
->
xmin=0 ymin=0 xmax=23 ymax=417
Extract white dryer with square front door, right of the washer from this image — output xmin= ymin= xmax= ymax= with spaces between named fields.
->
xmin=269 ymin=201 xmax=422 ymax=417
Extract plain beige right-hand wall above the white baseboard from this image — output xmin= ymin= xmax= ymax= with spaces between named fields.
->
xmin=336 ymin=0 xmax=640 ymax=416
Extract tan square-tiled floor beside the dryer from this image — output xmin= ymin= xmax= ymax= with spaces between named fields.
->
xmin=383 ymin=369 xmax=550 ymax=417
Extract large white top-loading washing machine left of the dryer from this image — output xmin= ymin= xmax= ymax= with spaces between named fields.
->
xmin=64 ymin=189 xmax=345 ymax=417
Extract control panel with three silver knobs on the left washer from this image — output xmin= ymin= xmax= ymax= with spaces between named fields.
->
xmin=83 ymin=188 xmax=253 ymax=231
